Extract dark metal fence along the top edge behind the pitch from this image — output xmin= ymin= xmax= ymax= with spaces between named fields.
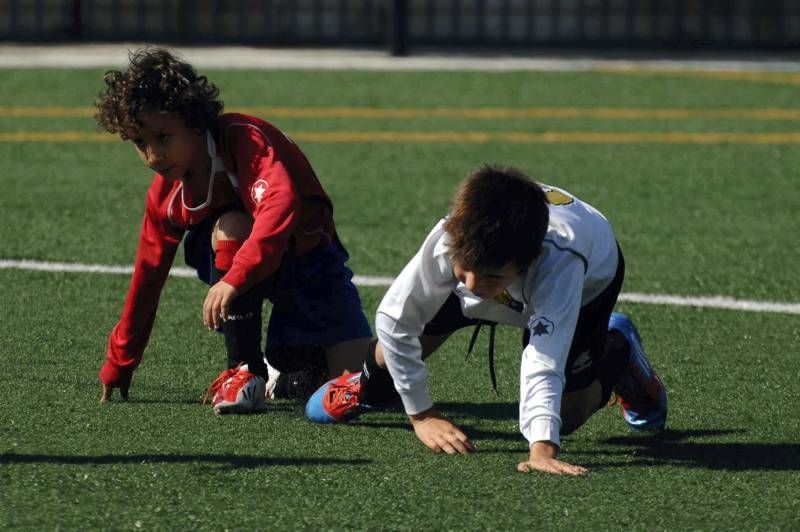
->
xmin=0 ymin=0 xmax=800 ymax=53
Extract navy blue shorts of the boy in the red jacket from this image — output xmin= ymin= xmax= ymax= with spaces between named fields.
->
xmin=184 ymin=213 xmax=372 ymax=350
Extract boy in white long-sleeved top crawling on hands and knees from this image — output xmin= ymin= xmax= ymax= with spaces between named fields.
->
xmin=306 ymin=166 xmax=667 ymax=475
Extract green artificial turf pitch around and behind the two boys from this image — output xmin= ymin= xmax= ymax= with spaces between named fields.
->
xmin=0 ymin=64 xmax=800 ymax=530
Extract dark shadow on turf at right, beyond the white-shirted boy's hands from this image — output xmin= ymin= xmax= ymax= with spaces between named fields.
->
xmin=596 ymin=429 xmax=800 ymax=471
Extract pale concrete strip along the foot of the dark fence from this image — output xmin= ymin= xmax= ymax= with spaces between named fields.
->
xmin=0 ymin=42 xmax=800 ymax=72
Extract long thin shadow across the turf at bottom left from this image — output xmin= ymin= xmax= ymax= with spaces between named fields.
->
xmin=0 ymin=453 xmax=371 ymax=468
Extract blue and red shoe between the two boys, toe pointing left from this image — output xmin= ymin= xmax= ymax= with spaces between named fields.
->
xmin=306 ymin=372 xmax=372 ymax=423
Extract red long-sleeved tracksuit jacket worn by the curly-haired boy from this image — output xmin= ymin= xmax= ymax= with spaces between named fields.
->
xmin=100 ymin=113 xmax=336 ymax=384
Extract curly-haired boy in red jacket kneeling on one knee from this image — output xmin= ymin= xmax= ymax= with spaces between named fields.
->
xmin=96 ymin=48 xmax=371 ymax=414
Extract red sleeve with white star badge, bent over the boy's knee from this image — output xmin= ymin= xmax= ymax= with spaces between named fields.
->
xmin=222 ymin=124 xmax=301 ymax=293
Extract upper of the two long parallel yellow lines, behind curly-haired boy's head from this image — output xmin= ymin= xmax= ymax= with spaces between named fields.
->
xmin=0 ymin=106 xmax=800 ymax=120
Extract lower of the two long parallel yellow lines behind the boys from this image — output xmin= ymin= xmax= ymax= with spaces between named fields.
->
xmin=0 ymin=131 xmax=800 ymax=144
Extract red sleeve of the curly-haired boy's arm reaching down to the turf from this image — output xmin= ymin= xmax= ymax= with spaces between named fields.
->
xmin=100 ymin=181 xmax=183 ymax=384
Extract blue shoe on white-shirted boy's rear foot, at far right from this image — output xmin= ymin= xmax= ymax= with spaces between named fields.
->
xmin=608 ymin=312 xmax=667 ymax=431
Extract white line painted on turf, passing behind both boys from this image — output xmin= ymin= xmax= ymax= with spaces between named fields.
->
xmin=0 ymin=259 xmax=800 ymax=314
